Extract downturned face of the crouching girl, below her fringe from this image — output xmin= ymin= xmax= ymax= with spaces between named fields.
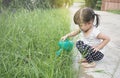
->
xmin=80 ymin=21 xmax=93 ymax=32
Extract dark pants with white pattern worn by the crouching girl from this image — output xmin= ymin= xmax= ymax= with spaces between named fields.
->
xmin=76 ymin=40 xmax=104 ymax=63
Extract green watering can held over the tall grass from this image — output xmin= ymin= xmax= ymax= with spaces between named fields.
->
xmin=56 ymin=39 xmax=73 ymax=56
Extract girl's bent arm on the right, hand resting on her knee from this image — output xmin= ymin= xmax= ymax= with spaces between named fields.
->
xmin=95 ymin=33 xmax=110 ymax=51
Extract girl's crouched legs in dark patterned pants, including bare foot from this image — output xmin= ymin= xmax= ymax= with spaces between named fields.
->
xmin=76 ymin=40 xmax=104 ymax=68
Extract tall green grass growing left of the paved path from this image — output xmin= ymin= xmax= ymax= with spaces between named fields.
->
xmin=0 ymin=9 xmax=73 ymax=78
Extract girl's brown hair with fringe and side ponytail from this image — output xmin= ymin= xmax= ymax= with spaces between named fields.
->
xmin=74 ymin=7 xmax=100 ymax=27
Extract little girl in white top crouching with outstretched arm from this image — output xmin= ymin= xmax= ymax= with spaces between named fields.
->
xmin=61 ymin=7 xmax=110 ymax=68
